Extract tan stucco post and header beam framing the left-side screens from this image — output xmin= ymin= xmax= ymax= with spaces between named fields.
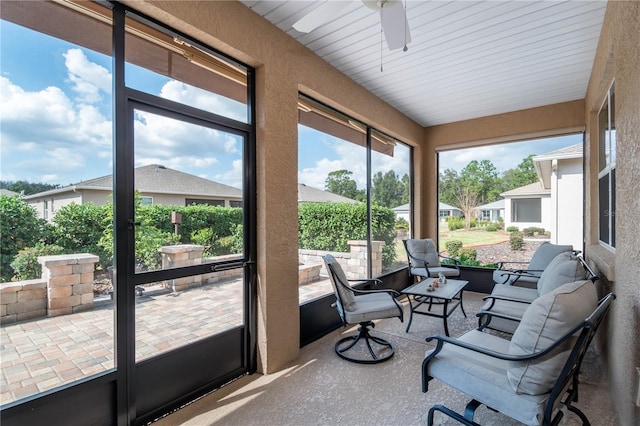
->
xmin=126 ymin=1 xmax=422 ymax=373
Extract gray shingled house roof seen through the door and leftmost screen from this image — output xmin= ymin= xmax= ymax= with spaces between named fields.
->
xmin=25 ymin=164 xmax=242 ymax=199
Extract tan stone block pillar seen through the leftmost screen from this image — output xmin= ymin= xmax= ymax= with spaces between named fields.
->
xmin=38 ymin=253 xmax=98 ymax=317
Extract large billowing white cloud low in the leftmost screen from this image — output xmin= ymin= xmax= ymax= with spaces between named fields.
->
xmin=0 ymin=77 xmax=111 ymax=184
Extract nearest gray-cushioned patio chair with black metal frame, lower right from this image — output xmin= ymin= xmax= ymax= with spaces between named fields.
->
xmin=422 ymin=281 xmax=615 ymax=425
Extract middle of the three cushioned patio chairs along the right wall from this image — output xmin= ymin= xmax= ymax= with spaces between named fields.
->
xmin=476 ymin=252 xmax=598 ymax=333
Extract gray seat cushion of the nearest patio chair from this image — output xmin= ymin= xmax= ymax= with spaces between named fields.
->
xmin=427 ymin=330 xmax=548 ymax=425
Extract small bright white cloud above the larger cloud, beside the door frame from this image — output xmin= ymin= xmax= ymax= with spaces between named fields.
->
xmin=62 ymin=49 xmax=111 ymax=103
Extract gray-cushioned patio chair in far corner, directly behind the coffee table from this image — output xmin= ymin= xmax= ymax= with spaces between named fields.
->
xmin=402 ymin=238 xmax=460 ymax=280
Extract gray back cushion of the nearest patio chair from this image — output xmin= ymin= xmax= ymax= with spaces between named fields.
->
xmin=507 ymin=280 xmax=598 ymax=395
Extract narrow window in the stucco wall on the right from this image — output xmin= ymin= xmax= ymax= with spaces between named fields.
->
xmin=598 ymin=85 xmax=616 ymax=248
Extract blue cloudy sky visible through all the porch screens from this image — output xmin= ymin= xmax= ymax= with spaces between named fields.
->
xmin=0 ymin=21 xmax=581 ymax=193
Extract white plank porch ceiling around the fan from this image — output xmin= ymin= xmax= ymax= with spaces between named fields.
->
xmin=242 ymin=0 xmax=606 ymax=126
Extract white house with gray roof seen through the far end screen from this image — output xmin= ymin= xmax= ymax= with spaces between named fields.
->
xmin=500 ymin=143 xmax=584 ymax=250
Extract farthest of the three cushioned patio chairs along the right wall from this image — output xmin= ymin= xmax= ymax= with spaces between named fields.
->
xmin=493 ymin=241 xmax=577 ymax=288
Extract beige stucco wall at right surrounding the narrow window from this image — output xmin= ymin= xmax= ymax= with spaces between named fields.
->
xmin=585 ymin=1 xmax=640 ymax=425
